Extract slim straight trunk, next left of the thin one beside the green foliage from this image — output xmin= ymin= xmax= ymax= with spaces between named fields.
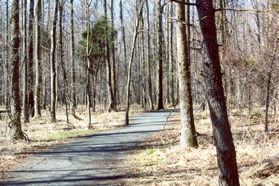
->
xmin=70 ymin=0 xmax=77 ymax=109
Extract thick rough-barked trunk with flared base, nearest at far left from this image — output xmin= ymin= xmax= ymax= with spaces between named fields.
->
xmin=10 ymin=0 xmax=24 ymax=140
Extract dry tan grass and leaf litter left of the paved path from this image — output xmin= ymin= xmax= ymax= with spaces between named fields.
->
xmin=0 ymin=105 xmax=143 ymax=179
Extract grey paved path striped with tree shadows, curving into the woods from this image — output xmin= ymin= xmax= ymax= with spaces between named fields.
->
xmin=0 ymin=111 xmax=176 ymax=185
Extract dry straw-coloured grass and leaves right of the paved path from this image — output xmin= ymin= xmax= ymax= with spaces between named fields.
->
xmin=122 ymin=107 xmax=279 ymax=185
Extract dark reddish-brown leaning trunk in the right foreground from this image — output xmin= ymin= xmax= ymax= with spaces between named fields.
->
xmin=196 ymin=0 xmax=239 ymax=186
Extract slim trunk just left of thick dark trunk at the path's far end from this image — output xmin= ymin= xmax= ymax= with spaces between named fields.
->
xmin=146 ymin=0 xmax=154 ymax=110
